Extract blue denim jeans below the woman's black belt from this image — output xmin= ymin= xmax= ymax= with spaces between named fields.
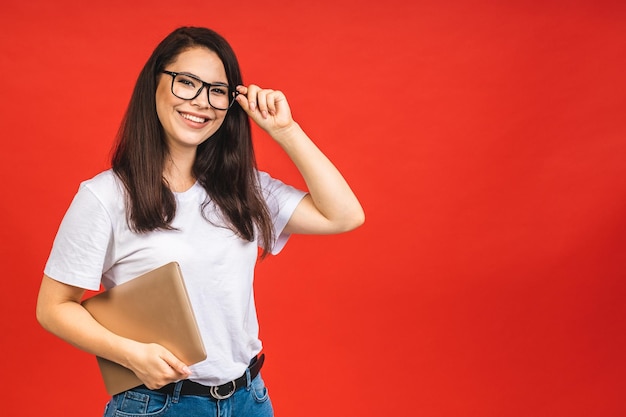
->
xmin=104 ymin=370 xmax=274 ymax=417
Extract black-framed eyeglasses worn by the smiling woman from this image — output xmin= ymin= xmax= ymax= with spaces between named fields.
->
xmin=163 ymin=71 xmax=239 ymax=110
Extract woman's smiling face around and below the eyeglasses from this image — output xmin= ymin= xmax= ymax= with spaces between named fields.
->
xmin=156 ymin=47 xmax=228 ymax=151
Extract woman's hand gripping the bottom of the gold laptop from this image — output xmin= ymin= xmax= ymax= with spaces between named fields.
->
xmin=125 ymin=340 xmax=191 ymax=389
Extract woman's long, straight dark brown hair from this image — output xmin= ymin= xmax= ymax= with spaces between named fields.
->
xmin=111 ymin=27 xmax=273 ymax=256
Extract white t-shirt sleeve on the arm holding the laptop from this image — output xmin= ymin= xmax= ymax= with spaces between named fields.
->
xmin=44 ymin=184 xmax=113 ymax=290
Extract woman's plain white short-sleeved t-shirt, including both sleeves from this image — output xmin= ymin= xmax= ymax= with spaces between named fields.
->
xmin=44 ymin=170 xmax=305 ymax=385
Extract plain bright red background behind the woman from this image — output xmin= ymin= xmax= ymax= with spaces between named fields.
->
xmin=0 ymin=0 xmax=626 ymax=417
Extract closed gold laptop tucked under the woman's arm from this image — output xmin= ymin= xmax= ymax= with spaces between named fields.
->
xmin=82 ymin=262 xmax=206 ymax=395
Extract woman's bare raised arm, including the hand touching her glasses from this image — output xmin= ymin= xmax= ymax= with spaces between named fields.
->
xmin=237 ymin=85 xmax=365 ymax=234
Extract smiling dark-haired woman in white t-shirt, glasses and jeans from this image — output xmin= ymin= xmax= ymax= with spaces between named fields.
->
xmin=37 ymin=28 xmax=364 ymax=416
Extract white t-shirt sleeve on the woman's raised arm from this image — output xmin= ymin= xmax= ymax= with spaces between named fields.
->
xmin=259 ymin=172 xmax=307 ymax=255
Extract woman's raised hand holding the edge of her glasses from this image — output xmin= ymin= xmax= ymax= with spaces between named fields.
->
xmin=237 ymin=84 xmax=295 ymax=138
